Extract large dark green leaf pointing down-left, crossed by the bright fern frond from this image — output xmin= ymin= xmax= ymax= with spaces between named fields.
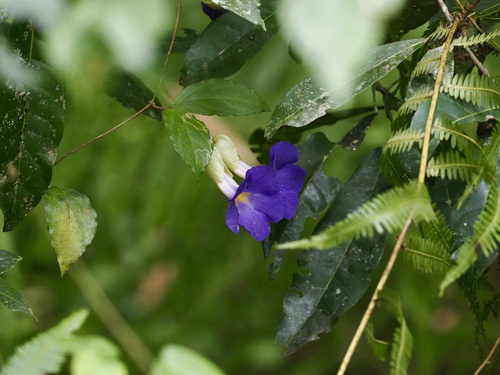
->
xmin=276 ymin=150 xmax=386 ymax=354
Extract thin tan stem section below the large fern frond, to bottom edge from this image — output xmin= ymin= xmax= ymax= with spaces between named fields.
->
xmin=337 ymin=215 xmax=412 ymax=375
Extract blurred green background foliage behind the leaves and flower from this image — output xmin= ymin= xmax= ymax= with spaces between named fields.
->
xmin=0 ymin=0 xmax=499 ymax=375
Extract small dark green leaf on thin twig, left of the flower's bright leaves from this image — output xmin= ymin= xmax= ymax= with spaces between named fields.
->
xmin=106 ymin=71 xmax=162 ymax=121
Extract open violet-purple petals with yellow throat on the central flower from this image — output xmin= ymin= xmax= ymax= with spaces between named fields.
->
xmin=226 ymin=142 xmax=306 ymax=241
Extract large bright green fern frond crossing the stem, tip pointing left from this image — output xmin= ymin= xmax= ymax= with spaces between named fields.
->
xmin=278 ymin=181 xmax=435 ymax=250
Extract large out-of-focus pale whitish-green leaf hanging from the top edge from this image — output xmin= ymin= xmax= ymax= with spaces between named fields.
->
xmin=279 ymin=0 xmax=411 ymax=92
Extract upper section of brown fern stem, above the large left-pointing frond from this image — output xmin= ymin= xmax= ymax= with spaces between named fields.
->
xmin=418 ymin=18 xmax=460 ymax=184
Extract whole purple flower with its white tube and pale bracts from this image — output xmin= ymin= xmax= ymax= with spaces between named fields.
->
xmin=208 ymin=136 xmax=306 ymax=241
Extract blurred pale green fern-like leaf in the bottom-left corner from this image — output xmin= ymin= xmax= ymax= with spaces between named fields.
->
xmin=0 ymin=310 xmax=88 ymax=375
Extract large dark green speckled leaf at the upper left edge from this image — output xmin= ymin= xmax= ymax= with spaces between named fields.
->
xmin=0 ymin=21 xmax=64 ymax=231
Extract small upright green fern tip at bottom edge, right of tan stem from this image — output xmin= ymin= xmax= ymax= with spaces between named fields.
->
xmin=389 ymin=317 xmax=413 ymax=375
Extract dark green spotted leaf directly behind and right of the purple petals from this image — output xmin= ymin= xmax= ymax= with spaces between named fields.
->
xmin=262 ymin=133 xmax=340 ymax=277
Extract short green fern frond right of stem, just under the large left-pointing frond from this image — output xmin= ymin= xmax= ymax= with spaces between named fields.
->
xmin=404 ymin=235 xmax=452 ymax=273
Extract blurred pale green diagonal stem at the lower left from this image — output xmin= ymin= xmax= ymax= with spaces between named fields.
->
xmin=69 ymin=259 xmax=154 ymax=374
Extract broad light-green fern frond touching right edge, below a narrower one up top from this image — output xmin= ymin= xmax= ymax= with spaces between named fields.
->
xmin=442 ymin=73 xmax=500 ymax=107
